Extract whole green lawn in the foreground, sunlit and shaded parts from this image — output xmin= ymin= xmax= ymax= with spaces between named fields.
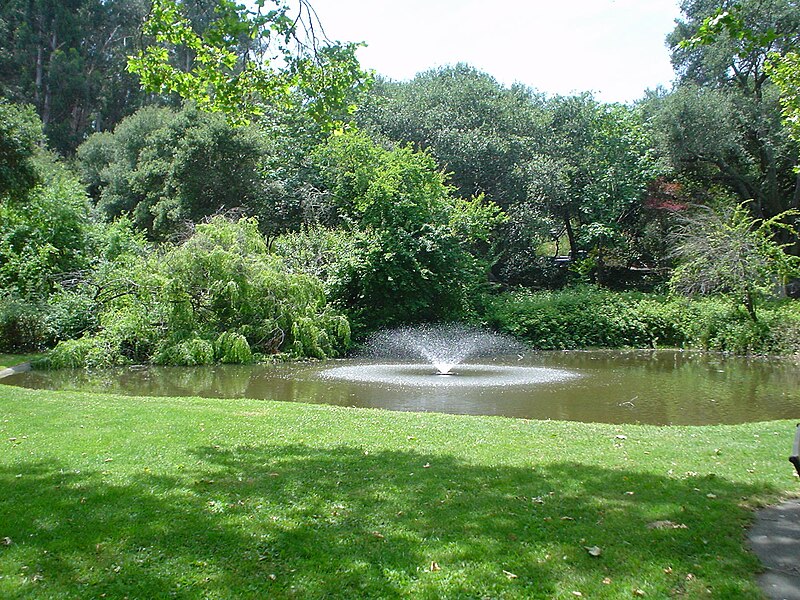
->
xmin=0 ymin=386 xmax=800 ymax=599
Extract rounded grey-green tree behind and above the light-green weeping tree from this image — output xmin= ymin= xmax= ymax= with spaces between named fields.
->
xmin=78 ymin=106 xmax=270 ymax=239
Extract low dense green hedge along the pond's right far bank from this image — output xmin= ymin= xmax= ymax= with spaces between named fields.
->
xmin=486 ymin=287 xmax=800 ymax=354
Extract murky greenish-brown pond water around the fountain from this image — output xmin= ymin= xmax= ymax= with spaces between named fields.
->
xmin=0 ymin=350 xmax=800 ymax=425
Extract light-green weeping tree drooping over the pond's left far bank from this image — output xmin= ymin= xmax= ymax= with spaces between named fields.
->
xmin=45 ymin=217 xmax=350 ymax=366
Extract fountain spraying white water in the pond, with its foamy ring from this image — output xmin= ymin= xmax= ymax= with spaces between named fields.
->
xmin=321 ymin=324 xmax=576 ymax=387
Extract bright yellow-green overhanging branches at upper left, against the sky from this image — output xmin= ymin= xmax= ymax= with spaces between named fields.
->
xmin=128 ymin=0 xmax=368 ymax=125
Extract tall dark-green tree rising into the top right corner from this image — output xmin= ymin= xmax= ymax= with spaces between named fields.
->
xmin=660 ymin=0 xmax=800 ymax=218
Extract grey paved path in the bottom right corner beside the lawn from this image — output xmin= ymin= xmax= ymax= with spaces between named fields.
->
xmin=748 ymin=499 xmax=800 ymax=600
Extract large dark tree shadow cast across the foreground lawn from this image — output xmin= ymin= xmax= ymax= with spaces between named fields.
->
xmin=0 ymin=444 xmax=768 ymax=598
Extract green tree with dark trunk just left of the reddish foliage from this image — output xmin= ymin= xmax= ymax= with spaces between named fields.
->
xmin=518 ymin=94 xmax=659 ymax=266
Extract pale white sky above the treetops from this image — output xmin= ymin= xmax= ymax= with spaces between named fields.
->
xmin=304 ymin=0 xmax=681 ymax=103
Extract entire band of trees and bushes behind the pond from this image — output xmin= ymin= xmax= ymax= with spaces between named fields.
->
xmin=0 ymin=0 xmax=800 ymax=365
